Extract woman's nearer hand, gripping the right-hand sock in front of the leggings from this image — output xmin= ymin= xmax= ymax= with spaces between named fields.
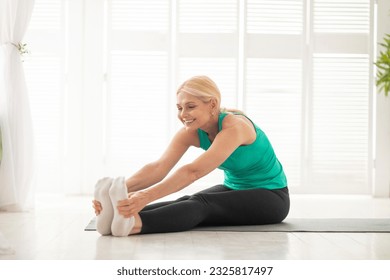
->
xmin=117 ymin=191 xmax=149 ymax=218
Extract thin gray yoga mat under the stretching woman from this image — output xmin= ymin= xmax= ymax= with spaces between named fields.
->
xmin=85 ymin=218 xmax=390 ymax=232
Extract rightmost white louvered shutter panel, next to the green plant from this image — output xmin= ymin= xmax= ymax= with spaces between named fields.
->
xmin=309 ymin=0 xmax=371 ymax=193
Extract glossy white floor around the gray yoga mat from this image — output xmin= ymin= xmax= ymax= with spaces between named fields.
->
xmin=0 ymin=195 xmax=390 ymax=260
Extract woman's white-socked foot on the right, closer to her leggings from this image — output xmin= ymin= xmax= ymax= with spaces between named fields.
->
xmin=109 ymin=177 xmax=134 ymax=236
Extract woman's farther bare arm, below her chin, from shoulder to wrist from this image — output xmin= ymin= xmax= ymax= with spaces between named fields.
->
xmin=126 ymin=128 xmax=197 ymax=193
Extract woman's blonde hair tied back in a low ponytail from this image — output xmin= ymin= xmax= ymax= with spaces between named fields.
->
xmin=176 ymin=76 xmax=244 ymax=114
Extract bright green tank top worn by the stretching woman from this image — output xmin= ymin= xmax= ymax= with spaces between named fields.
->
xmin=198 ymin=113 xmax=287 ymax=190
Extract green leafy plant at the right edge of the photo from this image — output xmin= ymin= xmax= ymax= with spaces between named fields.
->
xmin=375 ymin=34 xmax=390 ymax=96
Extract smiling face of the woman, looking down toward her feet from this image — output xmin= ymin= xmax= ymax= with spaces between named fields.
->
xmin=176 ymin=92 xmax=218 ymax=132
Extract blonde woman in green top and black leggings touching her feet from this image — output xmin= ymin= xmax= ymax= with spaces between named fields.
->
xmin=93 ymin=76 xmax=290 ymax=236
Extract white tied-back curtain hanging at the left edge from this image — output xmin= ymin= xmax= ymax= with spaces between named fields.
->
xmin=0 ymin=0 xmax=34 ymax=211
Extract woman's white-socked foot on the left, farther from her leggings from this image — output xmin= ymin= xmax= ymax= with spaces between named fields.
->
xmin=94 ymin=177 xmax=114 ymax=235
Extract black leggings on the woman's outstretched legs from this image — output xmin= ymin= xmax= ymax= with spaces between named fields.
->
xmin=139 ymin=185 xmax=290 ymax=233
